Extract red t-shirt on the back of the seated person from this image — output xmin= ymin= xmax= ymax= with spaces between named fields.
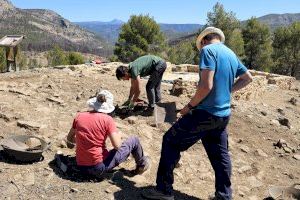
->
xmin=73 ymin=112 xmax=116 ymax=166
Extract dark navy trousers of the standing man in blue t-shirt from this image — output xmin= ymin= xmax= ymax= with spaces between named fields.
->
xmin=156 ymin=109 xmax=232 ymax=200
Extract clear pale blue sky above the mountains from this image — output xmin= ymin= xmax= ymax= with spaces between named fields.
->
xmin=10 ymin=0 xmax=300 ymax=24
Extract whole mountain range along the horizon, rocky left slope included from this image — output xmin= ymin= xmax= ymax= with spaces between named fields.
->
xmin=0 ymin=0 xmax=300 ymax=56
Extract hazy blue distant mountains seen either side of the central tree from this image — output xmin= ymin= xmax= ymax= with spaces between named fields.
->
xmin=74 ymin=19 xmax=201 ymax=44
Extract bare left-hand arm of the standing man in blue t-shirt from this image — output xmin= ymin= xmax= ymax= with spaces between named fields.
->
xmin=180 ymin=69 xmax=215 ymax=115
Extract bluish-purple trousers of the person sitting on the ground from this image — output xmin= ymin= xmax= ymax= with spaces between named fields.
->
xmin=78 ymin=137 xmax=146 ymax=177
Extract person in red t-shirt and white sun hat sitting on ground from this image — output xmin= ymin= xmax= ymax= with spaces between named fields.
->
xmin=67 ymin=90 xmax=149 ymax=177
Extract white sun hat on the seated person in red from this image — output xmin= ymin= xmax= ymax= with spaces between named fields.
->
xmin=87 ymin=90 xmax=115 ymax=113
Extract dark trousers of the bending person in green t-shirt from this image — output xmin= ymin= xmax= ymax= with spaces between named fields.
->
xmin=146 ymin=61 xmax=167 ymax=107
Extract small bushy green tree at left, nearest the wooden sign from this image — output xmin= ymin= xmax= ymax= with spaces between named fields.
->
xmin=47 ymin=45 xmax=68 ymax=66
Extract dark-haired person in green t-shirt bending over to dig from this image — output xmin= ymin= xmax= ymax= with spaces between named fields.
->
xmin=116 ymin=55 xmax=167 ymax=110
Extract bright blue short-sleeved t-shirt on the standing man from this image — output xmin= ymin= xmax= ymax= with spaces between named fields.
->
xmin=197 ymin=43 xmax=247 ymax=117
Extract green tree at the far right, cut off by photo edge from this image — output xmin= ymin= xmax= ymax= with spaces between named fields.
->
xmin=272 ymin=22 xmax=300 ymax=76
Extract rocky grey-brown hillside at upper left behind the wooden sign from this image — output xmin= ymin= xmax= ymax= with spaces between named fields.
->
xmin=0 ymin=0 xmax=110 ymax=55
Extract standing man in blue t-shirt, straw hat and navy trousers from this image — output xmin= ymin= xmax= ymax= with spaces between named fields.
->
xmin=144 ymin=27 xmax=252 ymax=200
